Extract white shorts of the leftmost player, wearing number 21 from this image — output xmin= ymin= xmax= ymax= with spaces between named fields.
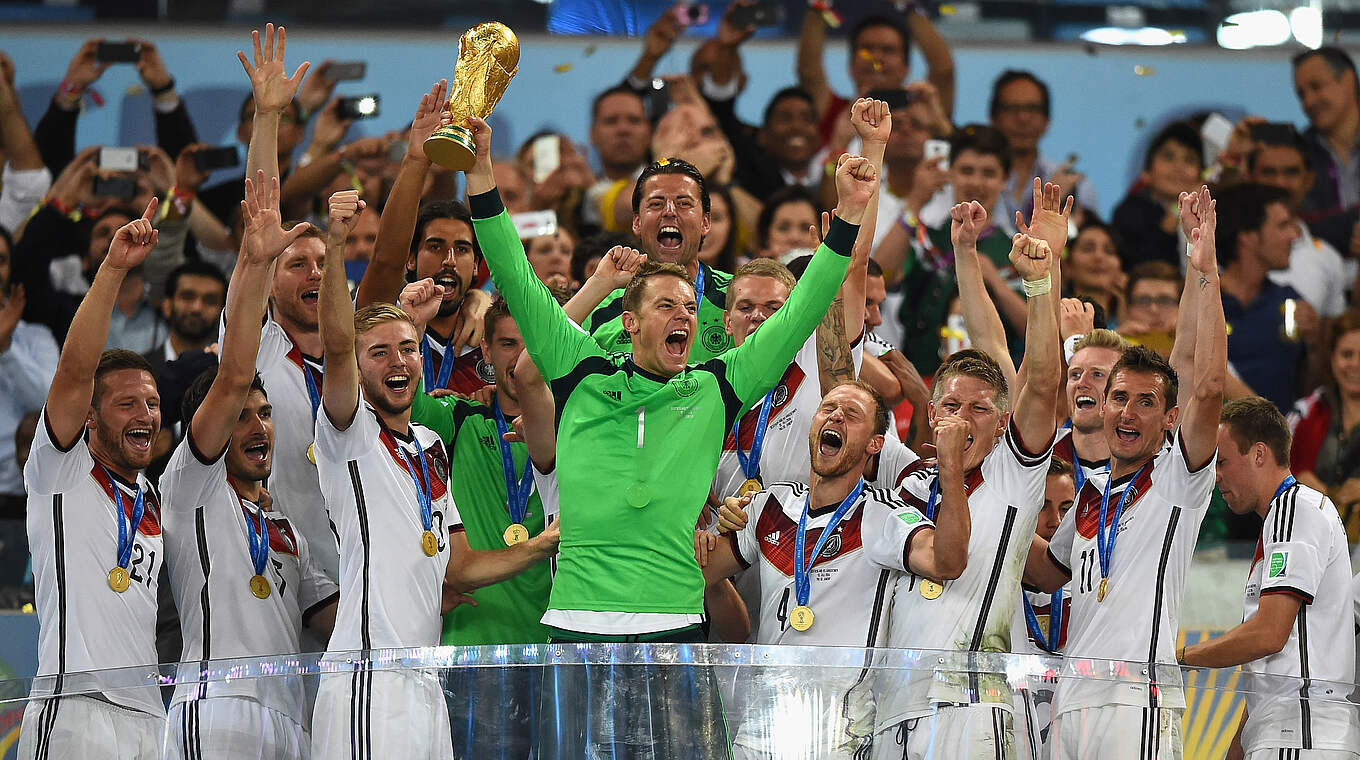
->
xmin=18 ymin=695 xmax=165 ymax=760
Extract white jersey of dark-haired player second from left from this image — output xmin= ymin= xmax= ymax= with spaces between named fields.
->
xmin=160 ymin=435 xmax=339 ymax=723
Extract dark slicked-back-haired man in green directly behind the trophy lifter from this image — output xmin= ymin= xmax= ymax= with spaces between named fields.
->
xmin=583 ymin=158 xmax=739 ymax=362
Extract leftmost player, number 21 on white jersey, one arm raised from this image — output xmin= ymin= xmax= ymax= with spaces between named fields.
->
xmin=19 ymin=198 xmax=165 ymax=760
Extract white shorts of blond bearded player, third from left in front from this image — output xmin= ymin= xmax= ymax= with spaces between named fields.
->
xmin=311 ymin=666 xmax=453 ymax=760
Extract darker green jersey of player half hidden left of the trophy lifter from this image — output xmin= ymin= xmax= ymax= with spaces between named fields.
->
xmin=411 ymin=393 xmax=552 ymax=646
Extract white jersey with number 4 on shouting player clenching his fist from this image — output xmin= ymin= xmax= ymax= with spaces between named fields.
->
xmin=728 ymin=483 xmax=933 ymax=748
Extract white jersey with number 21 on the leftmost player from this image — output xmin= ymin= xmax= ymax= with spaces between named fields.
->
xmin=23 ymin=409 xmax=165 ymax=716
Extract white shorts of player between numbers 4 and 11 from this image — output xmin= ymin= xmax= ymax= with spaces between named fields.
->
xmin=873 ymin=703 xmax=1016 ymax=760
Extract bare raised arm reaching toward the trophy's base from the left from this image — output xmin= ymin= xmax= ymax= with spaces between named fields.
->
xmin=354 ymin=79 xmax=449 ymax=307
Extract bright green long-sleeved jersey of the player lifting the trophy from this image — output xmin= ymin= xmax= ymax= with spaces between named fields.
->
xmin=468 ymin=190 xmax=858 ymax=615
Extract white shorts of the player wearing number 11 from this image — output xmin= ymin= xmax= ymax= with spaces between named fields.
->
xmin=1050 ymin=704 xmax=1183 ymax=760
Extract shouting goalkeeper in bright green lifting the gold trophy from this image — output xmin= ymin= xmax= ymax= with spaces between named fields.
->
xmin=468 ymin=118 xmax=877 ymax=759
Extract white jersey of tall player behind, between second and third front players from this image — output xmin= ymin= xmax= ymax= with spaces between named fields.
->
xmin=250 ymin=318 xmax=340 ymax=581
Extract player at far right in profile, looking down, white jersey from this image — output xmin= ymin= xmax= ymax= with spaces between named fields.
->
xmin=1178 ymin=396 xmax=1360 ymax=760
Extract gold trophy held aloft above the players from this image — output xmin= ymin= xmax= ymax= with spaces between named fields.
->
xmin=424 ymin=22 xmax=520 ymax=171
